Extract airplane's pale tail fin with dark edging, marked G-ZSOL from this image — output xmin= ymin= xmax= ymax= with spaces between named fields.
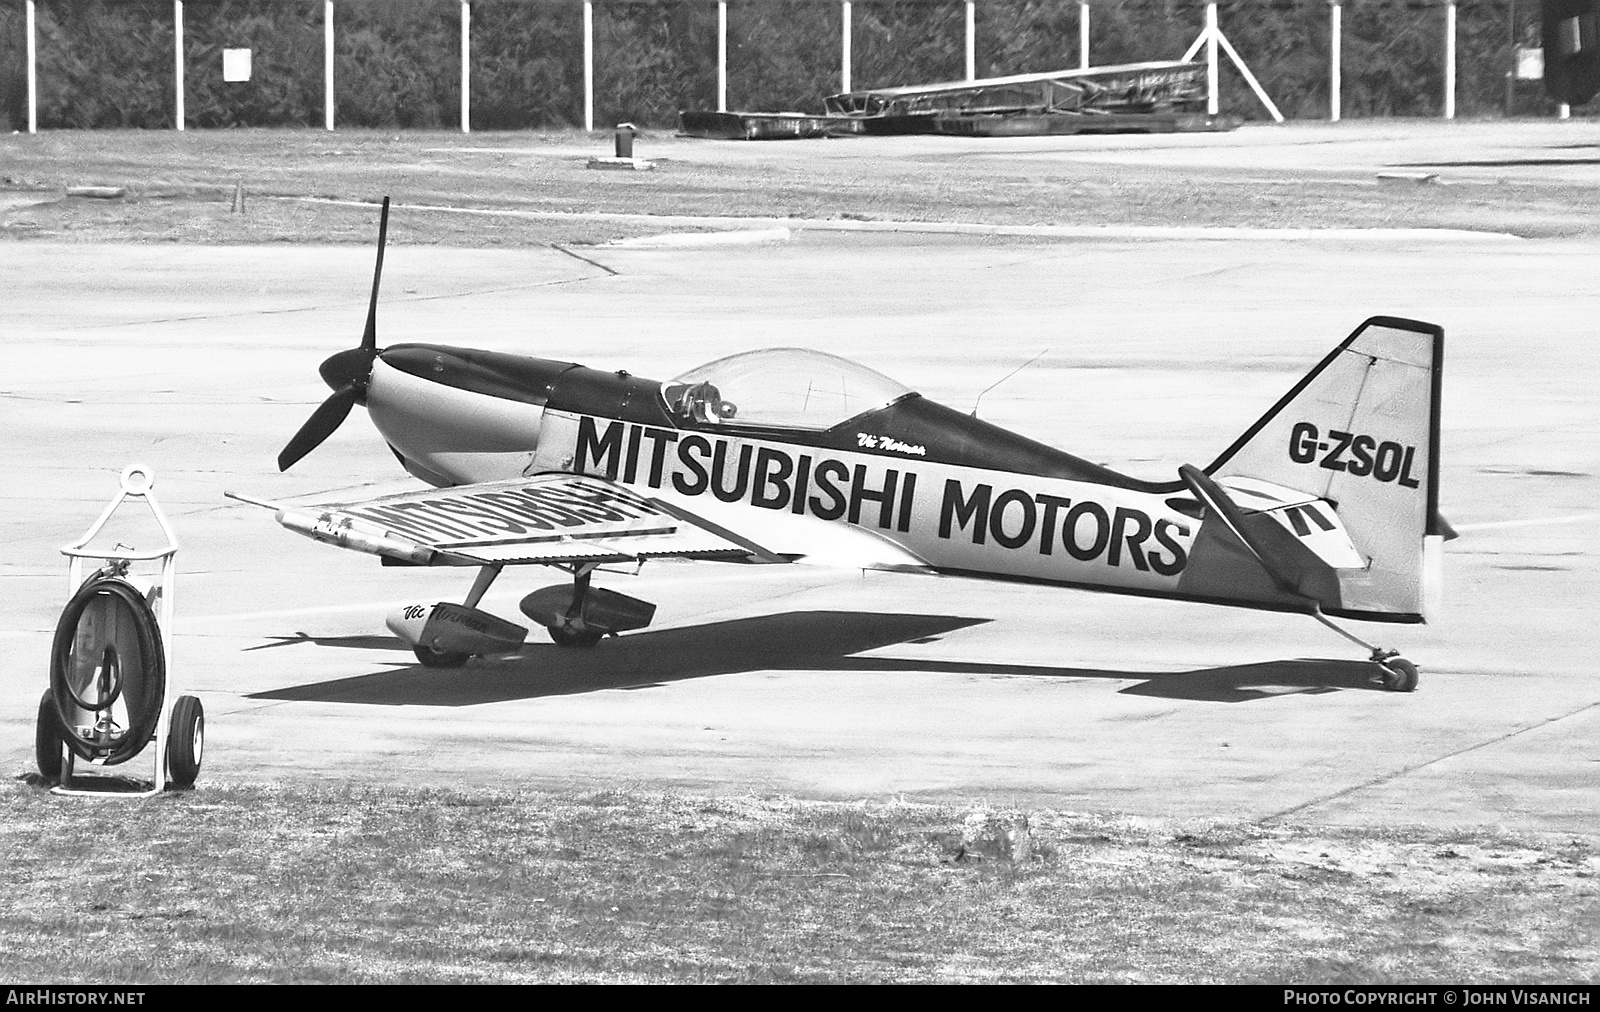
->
xmin=1205 ymin=317 xmax=1445 ymax=621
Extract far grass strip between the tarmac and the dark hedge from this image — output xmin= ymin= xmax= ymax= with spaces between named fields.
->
xmin=0 ymin=130 xmax=1600 ymax=247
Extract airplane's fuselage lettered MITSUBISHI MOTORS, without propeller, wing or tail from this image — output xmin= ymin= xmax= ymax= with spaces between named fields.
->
xmin=366 ymin=344 xmax=1298 ymax=607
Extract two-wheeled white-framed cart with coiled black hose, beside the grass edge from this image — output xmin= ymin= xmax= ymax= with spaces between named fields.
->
xmin=35 ymin=464 xmax=205 ymax=797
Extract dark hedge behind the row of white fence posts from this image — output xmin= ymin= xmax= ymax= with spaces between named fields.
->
xmin=0 ymin=0 xmax=1574 ymax=130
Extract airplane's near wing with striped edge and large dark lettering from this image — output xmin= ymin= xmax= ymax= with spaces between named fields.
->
xmin=234 ymin=474 xmax=786 ymax=565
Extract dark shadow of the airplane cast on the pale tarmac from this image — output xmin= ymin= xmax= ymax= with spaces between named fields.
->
xmin=248 ymin=612 xmax=1371 ymax=706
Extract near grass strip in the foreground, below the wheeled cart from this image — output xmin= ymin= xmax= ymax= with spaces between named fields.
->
xmin=0 ymin=778 xmax=1600 ymax=983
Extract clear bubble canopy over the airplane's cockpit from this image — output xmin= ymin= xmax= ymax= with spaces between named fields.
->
xmin=661 ymin=347 xmax=912 ymax=431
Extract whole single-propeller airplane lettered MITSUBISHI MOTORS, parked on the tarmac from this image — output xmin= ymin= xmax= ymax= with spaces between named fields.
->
xmin=230 ymin=199 xmax=1451 ymax=692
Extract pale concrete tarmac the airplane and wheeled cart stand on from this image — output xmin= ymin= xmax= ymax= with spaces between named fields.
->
xmin=0 ymin=124 xmax=1600 ymax=834
